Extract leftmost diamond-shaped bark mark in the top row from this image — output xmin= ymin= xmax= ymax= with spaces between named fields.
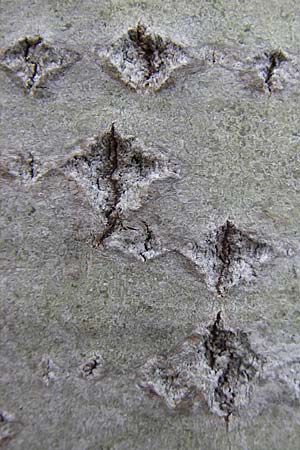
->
xmin=0 ymin=36 xmax=79 ymax=94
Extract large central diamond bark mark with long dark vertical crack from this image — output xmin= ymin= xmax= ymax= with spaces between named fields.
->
xmin=62 ymin=125 xmax=178 ymax=243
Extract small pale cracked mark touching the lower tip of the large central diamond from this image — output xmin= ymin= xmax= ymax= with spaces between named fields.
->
xmin=103 ymin=221 xmax=167 ymax=262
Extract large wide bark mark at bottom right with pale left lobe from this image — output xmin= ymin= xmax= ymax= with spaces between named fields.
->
xmin=138 ymin=313 xmax=262 ymax=420
